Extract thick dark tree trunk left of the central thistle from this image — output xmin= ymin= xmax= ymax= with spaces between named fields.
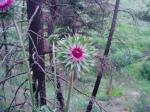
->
xmin=27 ymin=0 xmax=46 ymax=106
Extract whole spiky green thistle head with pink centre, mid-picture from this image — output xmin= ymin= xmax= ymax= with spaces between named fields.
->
xmin=56 ymin=35 xmax=96 ymax=77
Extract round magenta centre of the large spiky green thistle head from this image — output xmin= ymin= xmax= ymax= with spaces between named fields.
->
xmin=69 ymin=46 xmax=85 ymax=62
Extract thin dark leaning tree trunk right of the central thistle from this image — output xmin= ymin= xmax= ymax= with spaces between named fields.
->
xmin=86 ymin=0 xmax=120 ymax=112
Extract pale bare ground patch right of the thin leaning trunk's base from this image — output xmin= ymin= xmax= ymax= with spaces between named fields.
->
xmin=100 ymin=91 xmax=141 ymax=112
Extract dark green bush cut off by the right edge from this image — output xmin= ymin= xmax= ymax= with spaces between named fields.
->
xmin=140 ymin=60 xmax=150 ymax=81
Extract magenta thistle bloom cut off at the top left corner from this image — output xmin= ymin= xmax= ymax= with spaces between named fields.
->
xmin=0 ymin=0 xmax=14 ymax=11
